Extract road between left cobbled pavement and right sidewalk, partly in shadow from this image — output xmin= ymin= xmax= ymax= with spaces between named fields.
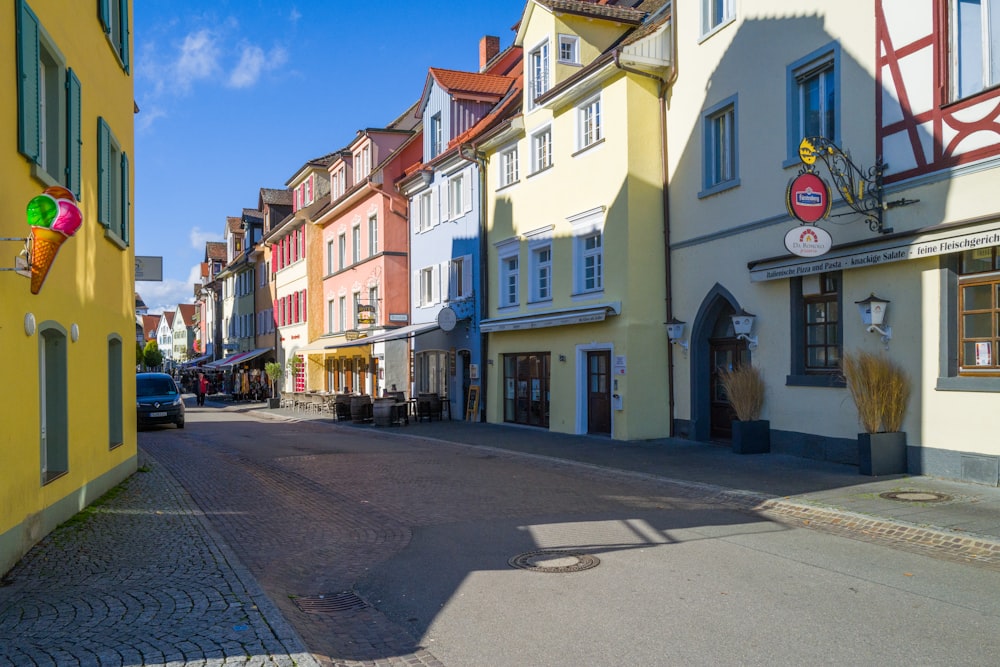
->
xmin=139 ymin=407 xmax=1000 ymax=667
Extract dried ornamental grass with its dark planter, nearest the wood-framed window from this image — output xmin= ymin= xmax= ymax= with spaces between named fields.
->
xmin=843 ymin=351 xmax=910 ymax=475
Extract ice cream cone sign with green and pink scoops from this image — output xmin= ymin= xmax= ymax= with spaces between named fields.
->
xmin=26 ymin=186 xmax=83 ymax=294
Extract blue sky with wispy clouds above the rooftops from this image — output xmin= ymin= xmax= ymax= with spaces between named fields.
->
xmin=132 ymin=0 xmax=524 ymax=312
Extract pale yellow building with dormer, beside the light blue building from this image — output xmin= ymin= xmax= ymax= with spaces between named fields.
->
xmin=477 ymin=0 xmax=670 ymax=440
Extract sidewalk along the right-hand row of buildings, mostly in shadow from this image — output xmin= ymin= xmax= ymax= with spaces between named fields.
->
xmin=244 ymin=404 xmax=1000 ymax=568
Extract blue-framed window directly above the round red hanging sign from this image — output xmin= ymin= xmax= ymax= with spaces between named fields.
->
xmin=784 ymin=42 xmax=840 ymax=167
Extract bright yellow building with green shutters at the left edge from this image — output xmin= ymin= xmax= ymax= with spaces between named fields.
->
xmin=0 ymin=0 xmax=136 ymax=573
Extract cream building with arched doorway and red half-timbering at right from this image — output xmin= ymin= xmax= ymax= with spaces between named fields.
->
xmin=667 ymin=0 xmax=1000 ymax=485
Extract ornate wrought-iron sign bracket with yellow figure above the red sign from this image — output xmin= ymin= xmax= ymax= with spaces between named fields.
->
xmin=799 ymin=137 xmax=920 ymax=234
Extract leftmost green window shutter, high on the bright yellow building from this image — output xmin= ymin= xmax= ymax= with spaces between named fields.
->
xmin=16 ymin=0 xmax=42 ymax=164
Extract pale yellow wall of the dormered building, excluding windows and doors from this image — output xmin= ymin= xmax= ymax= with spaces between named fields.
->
xmin=486 ymin=8 xmax=669 ymax=440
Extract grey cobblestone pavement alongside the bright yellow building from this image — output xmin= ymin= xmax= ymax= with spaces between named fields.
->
xmin=0 ymin=453 xmax=315 ymax=667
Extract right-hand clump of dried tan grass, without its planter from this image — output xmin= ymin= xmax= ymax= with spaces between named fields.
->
xmin=843 ymin=351 xmax=910 ymax=433
